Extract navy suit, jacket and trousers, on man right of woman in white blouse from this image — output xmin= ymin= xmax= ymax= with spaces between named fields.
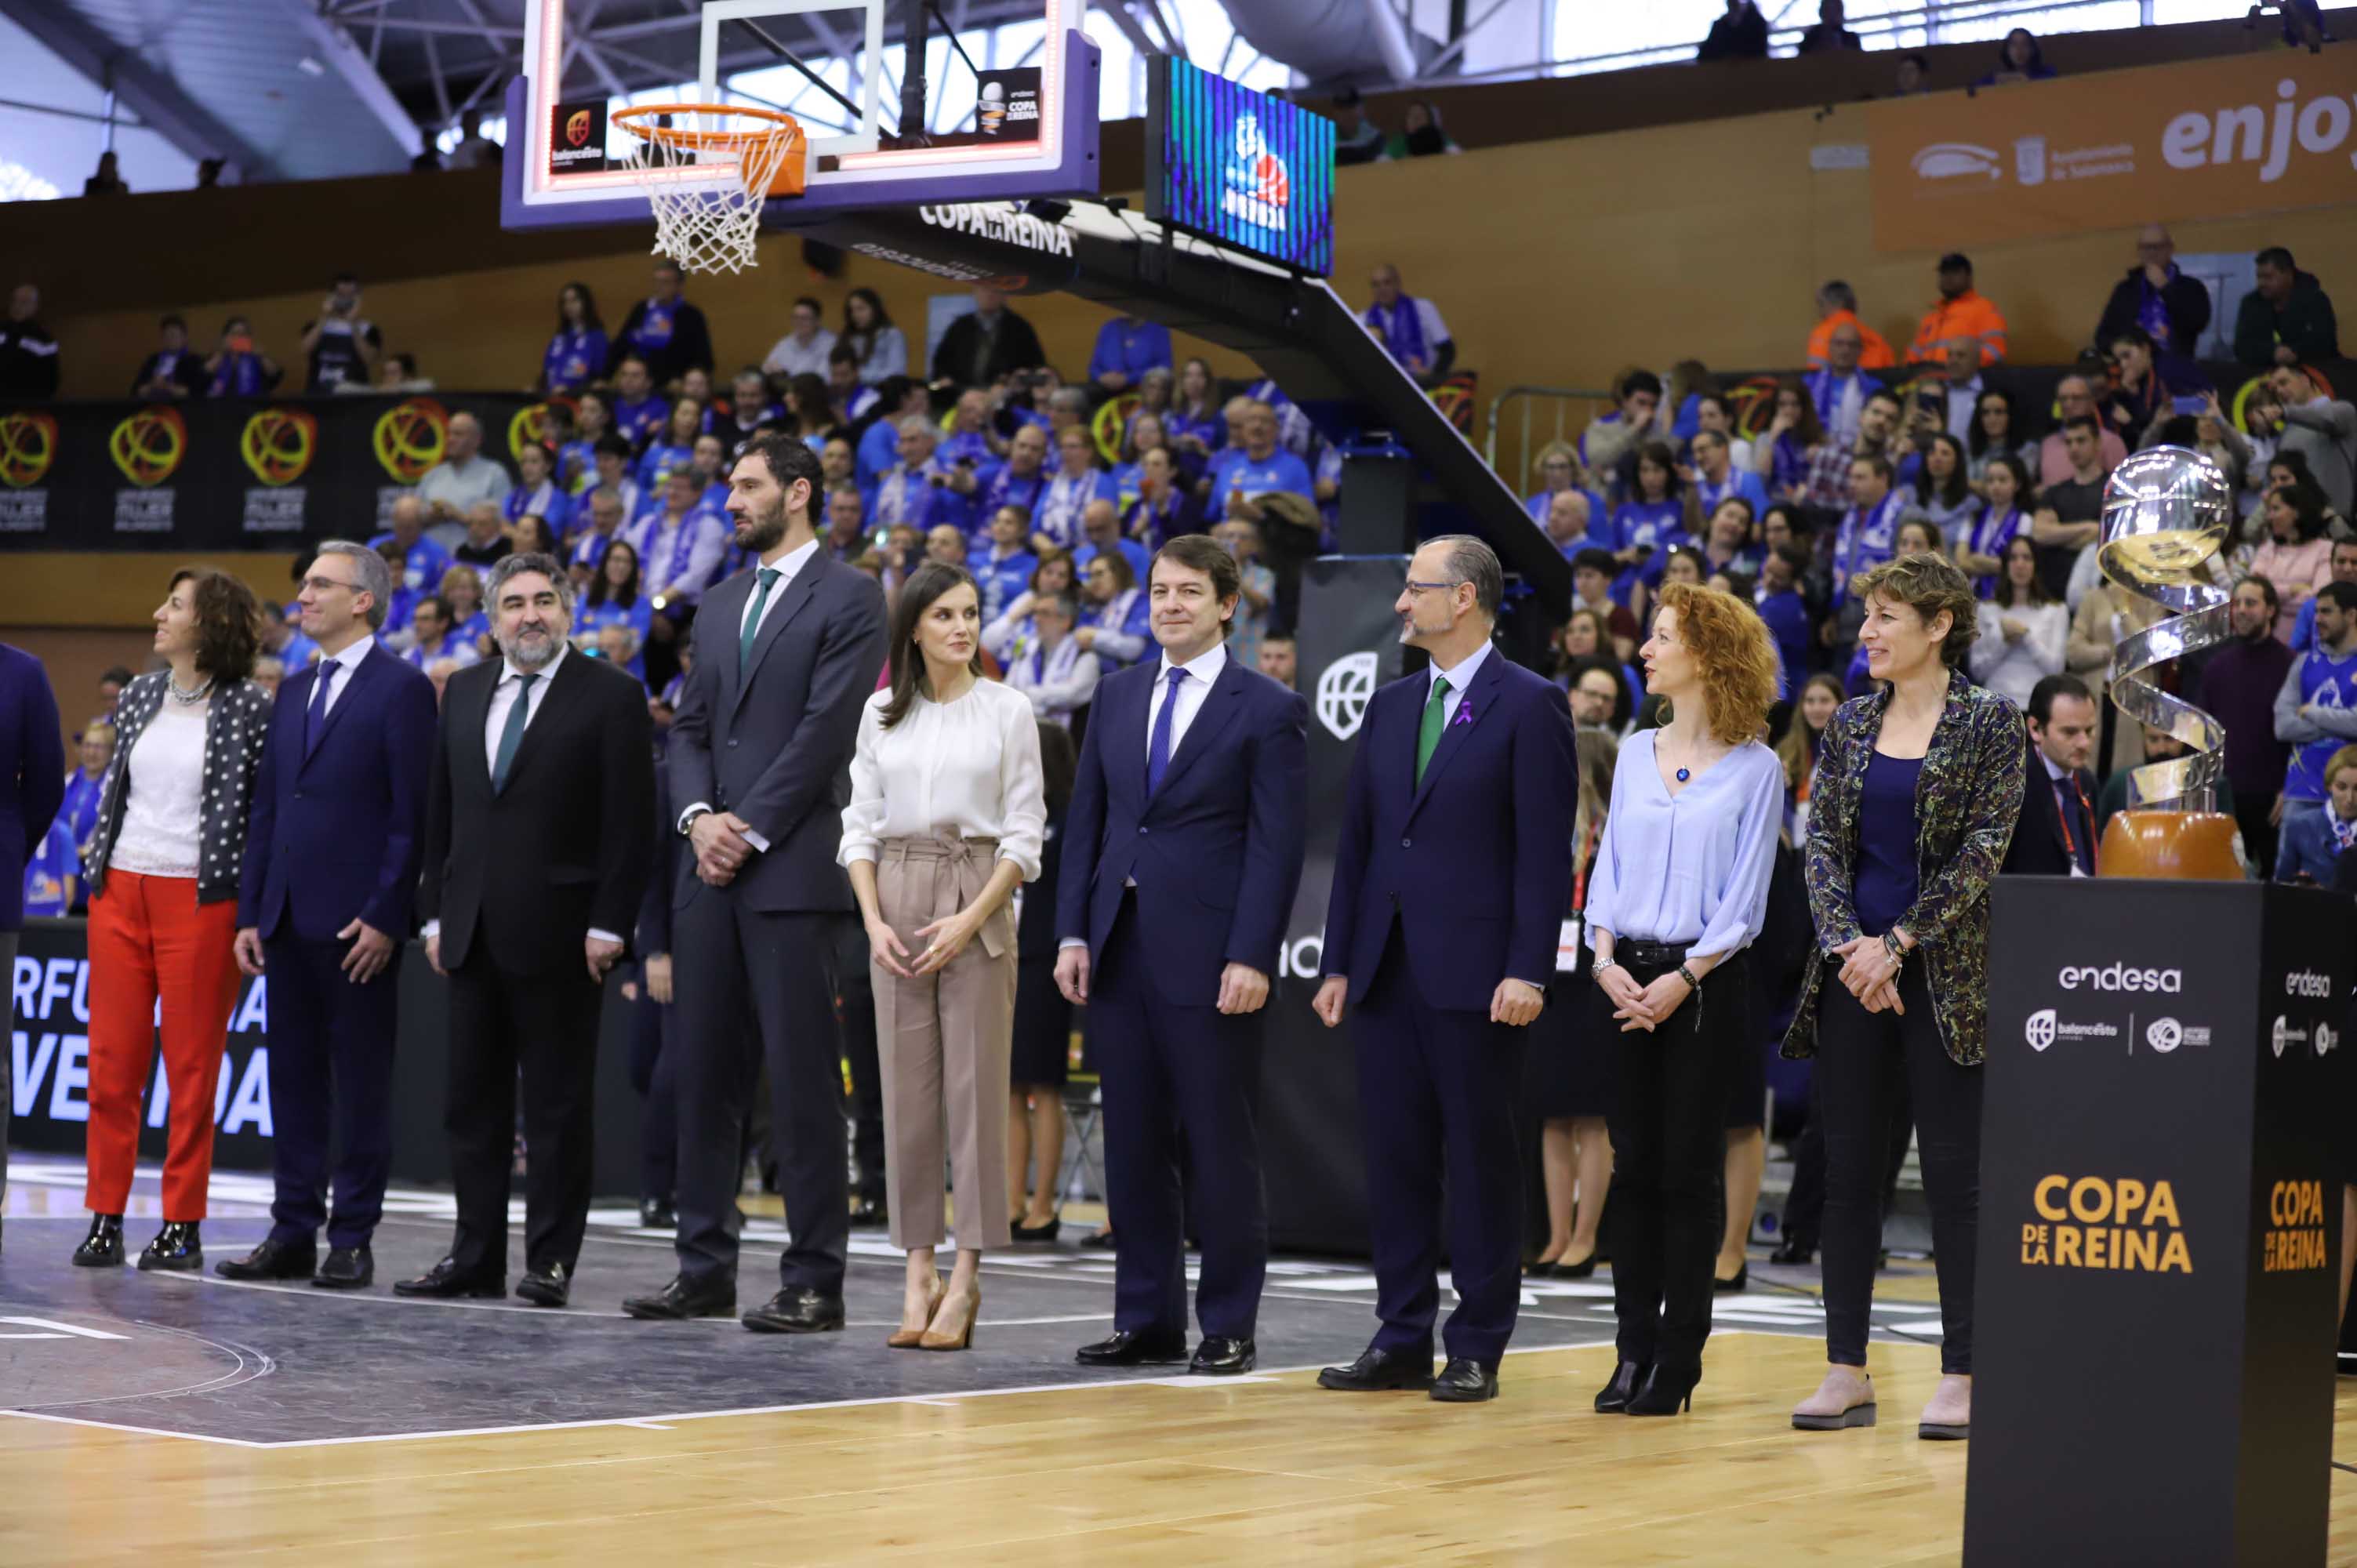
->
xmin=1056 ymin=655 xmax=1308 ymax=1339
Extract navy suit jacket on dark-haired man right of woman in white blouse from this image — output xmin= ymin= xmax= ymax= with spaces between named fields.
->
xmin=1056 ymin=651 xmax=1320 ymax=1007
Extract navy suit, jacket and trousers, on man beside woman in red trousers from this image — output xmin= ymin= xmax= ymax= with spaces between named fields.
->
xmin=238 ymin=648 xmax=434 ymax=1247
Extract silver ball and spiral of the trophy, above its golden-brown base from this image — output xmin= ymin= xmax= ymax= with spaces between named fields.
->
xmin=2095 ymin=445 xmax=2235 ymax=811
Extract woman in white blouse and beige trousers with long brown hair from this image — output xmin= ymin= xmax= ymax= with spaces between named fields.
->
xmin=837 ymin=561 xmax=1047 ymax=1351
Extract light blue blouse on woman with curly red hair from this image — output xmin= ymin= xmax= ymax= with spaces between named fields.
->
xmin=1586 ymin=728 xmax=1785 ymax=957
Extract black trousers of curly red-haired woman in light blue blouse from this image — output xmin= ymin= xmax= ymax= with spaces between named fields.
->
xmin=1598 ymin=953 xmax=1753 ymax=1372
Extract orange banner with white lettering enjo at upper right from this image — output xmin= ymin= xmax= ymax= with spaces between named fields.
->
xmin=1865 ymin=47 xmax=2357 ymax=252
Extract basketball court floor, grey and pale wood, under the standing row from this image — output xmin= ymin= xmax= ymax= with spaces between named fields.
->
xmin=0 ymin=1156 xmax=2357 ymax=1568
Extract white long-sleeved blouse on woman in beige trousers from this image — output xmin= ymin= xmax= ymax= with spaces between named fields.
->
xmin=834 ymin=679 xmax=1047 ymax=882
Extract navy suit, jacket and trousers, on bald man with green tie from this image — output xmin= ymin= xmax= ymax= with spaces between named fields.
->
xmin=1324 ymin=648 xmax=1579 ymax=1370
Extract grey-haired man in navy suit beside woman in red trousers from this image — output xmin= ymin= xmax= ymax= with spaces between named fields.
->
xmin=215 ymin=540 xmax=434 ymax=1290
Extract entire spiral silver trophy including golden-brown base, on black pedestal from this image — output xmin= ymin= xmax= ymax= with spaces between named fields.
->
xmin=2095 ymin=445 xmax=2244 ymax=882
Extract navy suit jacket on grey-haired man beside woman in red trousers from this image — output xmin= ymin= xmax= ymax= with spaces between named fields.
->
xmin=238 ymin=646 xmax=434 ymax=943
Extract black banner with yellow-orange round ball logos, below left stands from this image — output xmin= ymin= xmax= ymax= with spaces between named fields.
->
xmin=0 ymin=391 xmax=551 ymax=552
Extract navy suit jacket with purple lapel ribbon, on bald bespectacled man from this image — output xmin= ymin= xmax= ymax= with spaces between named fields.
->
xmin=1322 ymin=648 xmax=1579 ymax=1011
